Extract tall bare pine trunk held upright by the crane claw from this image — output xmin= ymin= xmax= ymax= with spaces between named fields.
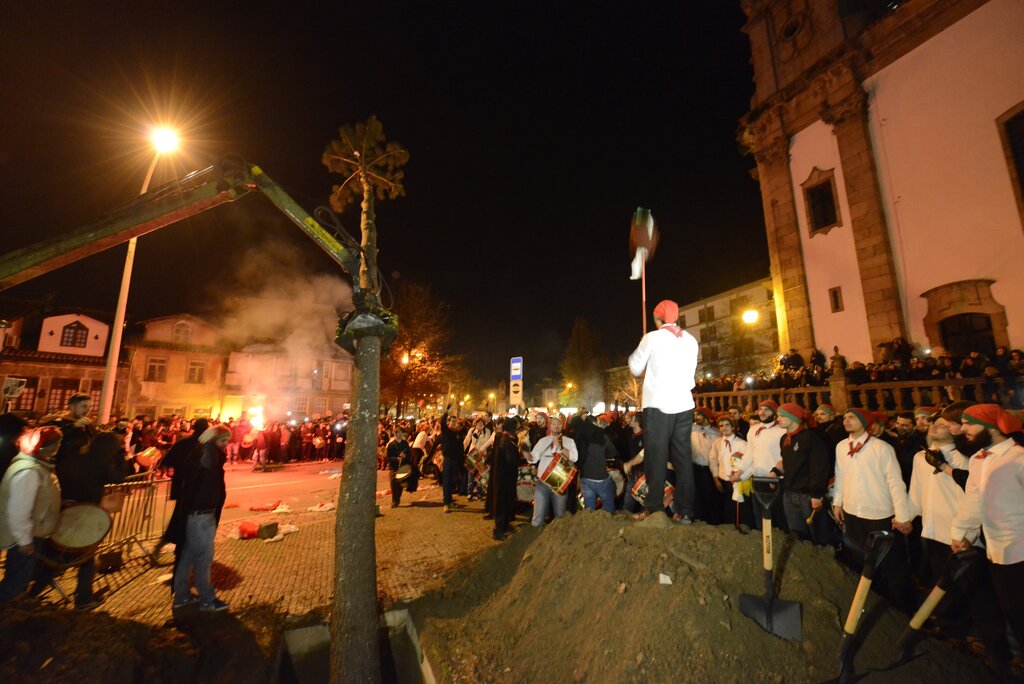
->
xmin=331 ymin=182 xmax=381 ymax=684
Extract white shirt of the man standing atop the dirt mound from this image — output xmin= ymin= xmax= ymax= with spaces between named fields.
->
xmin=629 ymin=329 xmax=697 ymax=414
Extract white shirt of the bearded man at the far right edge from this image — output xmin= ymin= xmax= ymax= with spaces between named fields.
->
xmin=950 ymin=439 xmax=1024 ymax=565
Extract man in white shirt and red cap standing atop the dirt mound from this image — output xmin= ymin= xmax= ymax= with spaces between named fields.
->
xmin=629 ymin=299 xmax=698 ymax=524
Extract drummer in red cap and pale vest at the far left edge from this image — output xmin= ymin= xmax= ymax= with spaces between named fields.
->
xmin=0 ymin=426 xmax=62 ymax=606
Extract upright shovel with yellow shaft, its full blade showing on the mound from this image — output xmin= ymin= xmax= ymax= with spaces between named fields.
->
xmin=739 ymin=477 xmax=801 ymax=641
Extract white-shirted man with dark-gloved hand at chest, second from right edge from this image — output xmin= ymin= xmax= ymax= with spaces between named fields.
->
xmin=908 ymin=411 xmax=1010 ymax=669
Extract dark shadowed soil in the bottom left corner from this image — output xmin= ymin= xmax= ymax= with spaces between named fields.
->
xmin=0 ymin=602 xmax=282 ymax=684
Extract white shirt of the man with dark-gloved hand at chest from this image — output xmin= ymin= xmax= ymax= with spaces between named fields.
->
xmin=907 ymin=444 xmax=968 ymax=545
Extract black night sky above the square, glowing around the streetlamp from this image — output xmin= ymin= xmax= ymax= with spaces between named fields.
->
xmin=0 ymin=0 xmax=768 ymax=382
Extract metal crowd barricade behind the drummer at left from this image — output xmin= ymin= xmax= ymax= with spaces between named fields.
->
xmin=98 ymin=472 xmax=170 ymax=561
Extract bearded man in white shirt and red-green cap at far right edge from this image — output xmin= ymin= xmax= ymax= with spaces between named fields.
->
xmin=950 ymin=403 xmax=1024 ymax=643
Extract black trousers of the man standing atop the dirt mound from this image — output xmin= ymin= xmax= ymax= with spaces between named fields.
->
xmin=643 ymin=409 xmax=696 ymax=518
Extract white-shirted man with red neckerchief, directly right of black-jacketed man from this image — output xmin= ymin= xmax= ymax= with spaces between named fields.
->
xmin=833 ymin=409 xmax=913 ymax=609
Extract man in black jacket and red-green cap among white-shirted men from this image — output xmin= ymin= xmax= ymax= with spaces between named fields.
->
xmin=778 ymin=403 xmax=835 ymax=546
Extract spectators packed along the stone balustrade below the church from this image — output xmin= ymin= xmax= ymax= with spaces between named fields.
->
xmin=693 ymin=338 xmax=1024 ymax=409
